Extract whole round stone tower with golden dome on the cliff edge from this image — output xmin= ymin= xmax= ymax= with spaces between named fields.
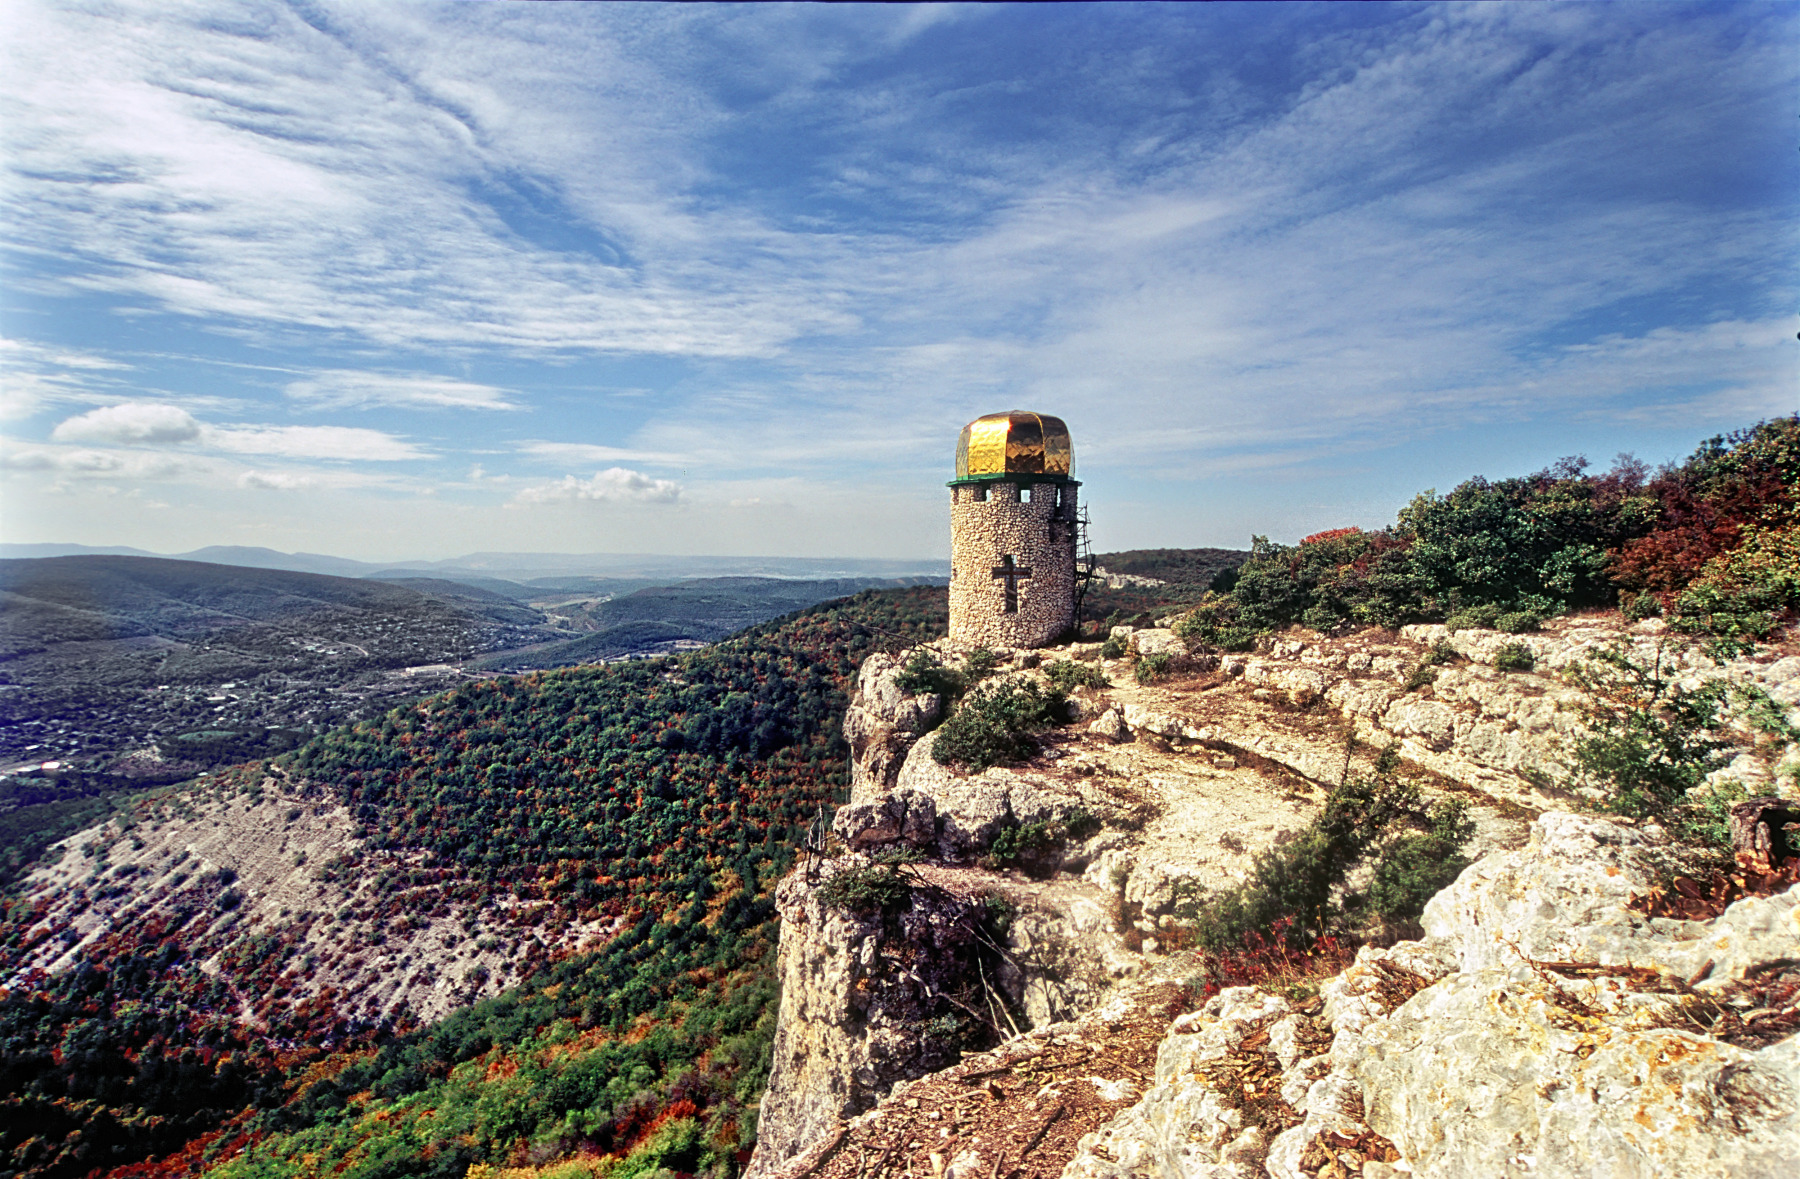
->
xmin=950 ymin=410 xmax=1082 ymax=646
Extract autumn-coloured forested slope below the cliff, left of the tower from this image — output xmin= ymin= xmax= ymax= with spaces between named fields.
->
xmin=0 ymin=589 xmax=945 ymax=1179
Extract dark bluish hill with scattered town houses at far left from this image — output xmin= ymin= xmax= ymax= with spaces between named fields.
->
xmin=0 ymin=556 xmax=562 ymax=781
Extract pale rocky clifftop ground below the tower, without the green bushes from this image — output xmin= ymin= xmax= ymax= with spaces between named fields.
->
xmin=751 ymin=617 xmax=1800 ymax=1179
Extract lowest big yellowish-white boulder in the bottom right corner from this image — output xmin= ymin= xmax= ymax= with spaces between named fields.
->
xmin=1334 ymin=970 xmax=1800 ymax=1179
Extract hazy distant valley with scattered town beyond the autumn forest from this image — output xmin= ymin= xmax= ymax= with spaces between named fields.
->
xmin=0 ymin=556 xmax=950 ymax=781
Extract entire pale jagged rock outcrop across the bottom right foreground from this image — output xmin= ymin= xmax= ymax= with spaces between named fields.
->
xmin=1064 ymin=814 xmax=1800 ymax=1179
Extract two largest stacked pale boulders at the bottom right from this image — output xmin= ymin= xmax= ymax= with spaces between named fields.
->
xmin=1317 ymin=814 xmax=1800 ymax=1179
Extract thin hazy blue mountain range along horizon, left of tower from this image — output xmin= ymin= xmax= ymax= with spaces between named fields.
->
xmin=0 ymin=544 xmax=950 ymax=594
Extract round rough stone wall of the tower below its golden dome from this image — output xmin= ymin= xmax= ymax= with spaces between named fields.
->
xmin=950 ymin=482 xmax=1075 ymax=646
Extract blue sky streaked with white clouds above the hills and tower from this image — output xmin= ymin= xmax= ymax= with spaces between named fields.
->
xmin=0 ymin=2 xmax=1800 ymax=560
